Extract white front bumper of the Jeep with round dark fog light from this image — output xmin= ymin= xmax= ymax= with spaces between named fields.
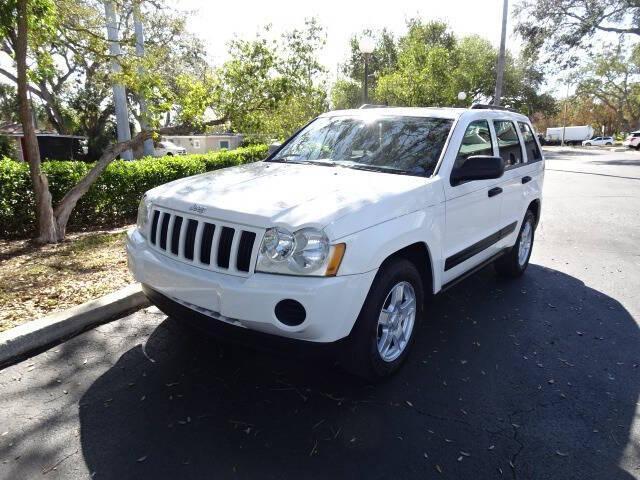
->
xmin=127 ymin=229 xmax=376 ymax=343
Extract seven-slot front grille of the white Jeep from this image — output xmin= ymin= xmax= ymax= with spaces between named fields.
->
xmin=149 ymin=207 xmax=262 ymax=275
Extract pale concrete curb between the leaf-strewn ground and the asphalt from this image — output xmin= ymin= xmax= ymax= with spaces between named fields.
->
xmin=0 ymin=283 xmax=149 ymax=367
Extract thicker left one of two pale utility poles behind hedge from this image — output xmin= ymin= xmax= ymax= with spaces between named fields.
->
xmin=104 ymin=0 xmax=133 ymax=160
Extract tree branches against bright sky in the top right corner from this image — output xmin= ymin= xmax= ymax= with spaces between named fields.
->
xmin=514 ymin=0 xmax=640 ymax=66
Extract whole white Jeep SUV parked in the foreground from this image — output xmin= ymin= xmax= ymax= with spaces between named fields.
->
xmin=127 ymin=108 xmax=544 ymax=378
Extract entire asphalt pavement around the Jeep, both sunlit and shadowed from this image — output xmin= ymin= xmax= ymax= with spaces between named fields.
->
xmin=0 ymin=148 xmax=640 ymax=480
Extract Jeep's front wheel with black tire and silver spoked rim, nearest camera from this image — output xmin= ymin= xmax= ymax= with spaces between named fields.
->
xmin=344 ymin=258 xmax=424 ymax=381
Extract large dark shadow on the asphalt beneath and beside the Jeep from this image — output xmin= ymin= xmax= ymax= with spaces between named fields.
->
xmin=79 ymin=265 xmax=640 ymax=479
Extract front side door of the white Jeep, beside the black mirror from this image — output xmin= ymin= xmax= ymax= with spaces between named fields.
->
xmin=442 ymin=119 xmax=503 ymax=284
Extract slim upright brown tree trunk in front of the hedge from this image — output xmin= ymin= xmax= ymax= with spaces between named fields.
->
xmin=16 ymin=0 xmax=58 ymax=243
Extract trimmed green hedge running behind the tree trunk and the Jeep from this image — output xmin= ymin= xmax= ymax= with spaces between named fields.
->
xmin=0 ymin=145 xmax=268 ymax=238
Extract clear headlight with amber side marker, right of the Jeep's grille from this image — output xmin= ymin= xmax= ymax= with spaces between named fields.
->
xmin=256 ymin=228 xmax=344 ymax=276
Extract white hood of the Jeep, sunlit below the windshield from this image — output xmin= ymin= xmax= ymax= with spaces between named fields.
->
xmin=148 ymin=162 xmax=432 ymax=236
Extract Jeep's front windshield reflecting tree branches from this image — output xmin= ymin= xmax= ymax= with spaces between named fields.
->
xmin=271 ymin=116 xmax=453 ymax=176
